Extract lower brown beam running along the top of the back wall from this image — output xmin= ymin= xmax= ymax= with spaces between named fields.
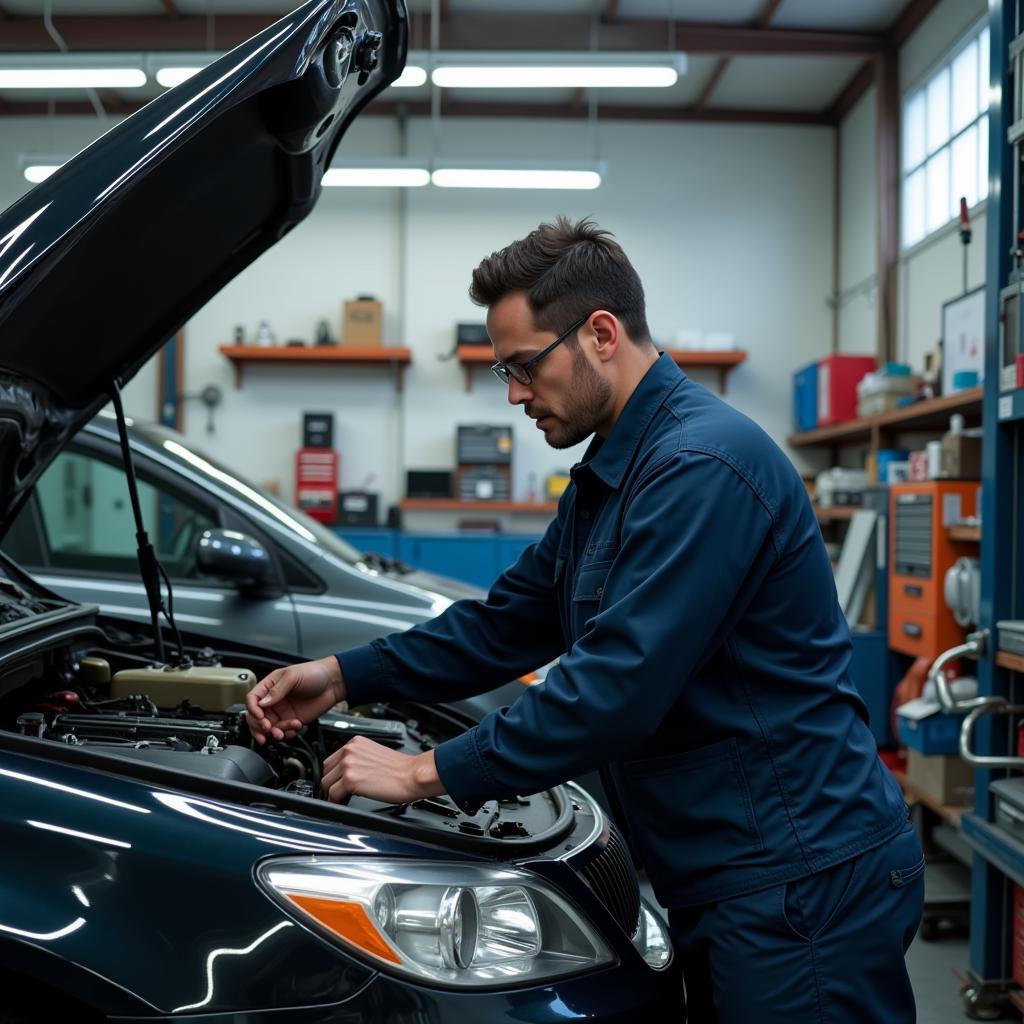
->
xmin=0 ymin=97 xmax=829 ymax=125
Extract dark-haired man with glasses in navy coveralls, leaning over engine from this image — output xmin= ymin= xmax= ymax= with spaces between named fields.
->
xmin=247 ymin=218 xmax=924 ymax=1024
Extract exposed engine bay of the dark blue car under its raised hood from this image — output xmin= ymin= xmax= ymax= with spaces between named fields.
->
xmin=0 ymin=580 xmax=561 ymax=840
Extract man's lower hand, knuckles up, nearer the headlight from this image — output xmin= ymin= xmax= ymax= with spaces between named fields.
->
xmin=323 ymin=736 xmax=445 ymax=804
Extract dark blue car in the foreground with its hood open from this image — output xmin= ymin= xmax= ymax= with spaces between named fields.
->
xmin=0 ymin=0 xmax=682 ymax=1024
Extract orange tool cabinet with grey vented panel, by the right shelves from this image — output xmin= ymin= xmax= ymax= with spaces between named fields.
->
xmin=889 ymin=480 xmax=979 ymax=658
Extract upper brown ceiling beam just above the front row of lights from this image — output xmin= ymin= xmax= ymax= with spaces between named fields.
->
xmin=0 ymin=12 xmax=885 ymax=57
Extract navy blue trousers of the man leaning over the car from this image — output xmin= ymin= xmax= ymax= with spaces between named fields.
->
xmin=669 ymin=821 xmax=925 ymax=1024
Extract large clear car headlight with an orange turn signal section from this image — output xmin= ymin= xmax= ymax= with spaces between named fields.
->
xmin=256 ymin=856 xmax=617 ymax=987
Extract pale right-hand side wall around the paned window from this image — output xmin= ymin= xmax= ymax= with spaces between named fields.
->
xmin=840 ymin=0 xmax=986 ymax=371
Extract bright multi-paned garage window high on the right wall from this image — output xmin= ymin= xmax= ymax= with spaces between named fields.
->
xmin=901 ymin=21 xmax=988 ymax=249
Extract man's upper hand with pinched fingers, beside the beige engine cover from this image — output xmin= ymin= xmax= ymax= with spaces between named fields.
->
xmin=246 ymin=656 xmax=345 ymax=745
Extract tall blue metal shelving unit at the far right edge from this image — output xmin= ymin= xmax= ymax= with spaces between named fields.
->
xmin=962 ymin=0 xmax=1024 ymax=1007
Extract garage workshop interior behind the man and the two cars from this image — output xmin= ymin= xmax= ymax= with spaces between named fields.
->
xmin=0 ymin=0 xmax=1024 ymax=1024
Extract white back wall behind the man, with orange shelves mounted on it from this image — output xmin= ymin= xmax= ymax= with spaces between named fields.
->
xmin=0 ymin=112 xmax=833 ymax=512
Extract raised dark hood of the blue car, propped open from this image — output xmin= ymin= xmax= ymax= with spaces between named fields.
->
xmin=0 ymin=0 xmax=408 ymax=536
